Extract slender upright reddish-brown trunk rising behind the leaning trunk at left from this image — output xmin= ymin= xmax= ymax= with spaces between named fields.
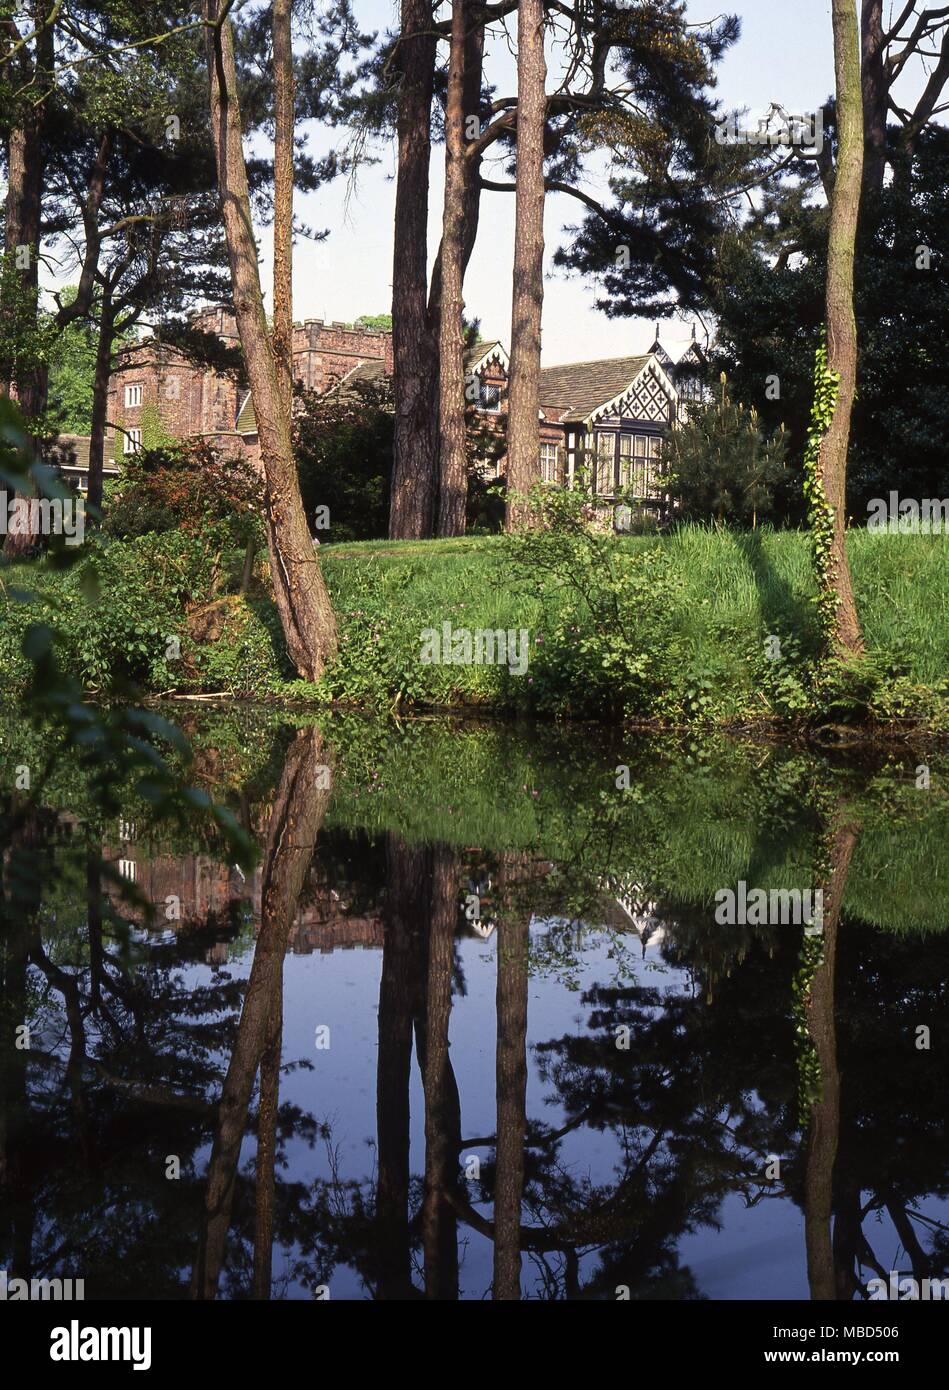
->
xmin=272 ymin=0 xmax=295 ymax=417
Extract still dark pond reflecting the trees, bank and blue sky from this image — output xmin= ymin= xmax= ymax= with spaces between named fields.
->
xmin=0 ymin=709 xmax=949 ymax=1301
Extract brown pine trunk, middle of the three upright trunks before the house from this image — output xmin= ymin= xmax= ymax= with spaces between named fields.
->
xmin=436 ymin=0 xmax=470 ymax=535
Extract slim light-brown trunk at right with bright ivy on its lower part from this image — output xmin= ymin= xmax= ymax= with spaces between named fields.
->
xmin=818 ymin=0 xmax=863 ymax=652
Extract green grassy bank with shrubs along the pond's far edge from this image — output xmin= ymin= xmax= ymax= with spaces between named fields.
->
xmin=0 ymin=527 xmax=949 ymax=730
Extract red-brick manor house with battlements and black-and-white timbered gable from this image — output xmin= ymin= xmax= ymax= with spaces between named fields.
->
xmin=61 ymin=306 xmax=704 ymax=502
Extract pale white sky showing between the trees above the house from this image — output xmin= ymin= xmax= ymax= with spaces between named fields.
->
xmin=275 ymin=0 xmax=834 ymax=366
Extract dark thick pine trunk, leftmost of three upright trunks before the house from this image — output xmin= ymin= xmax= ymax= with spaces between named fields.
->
xmin=389 ymin=0 xmax=438 ymax=539
